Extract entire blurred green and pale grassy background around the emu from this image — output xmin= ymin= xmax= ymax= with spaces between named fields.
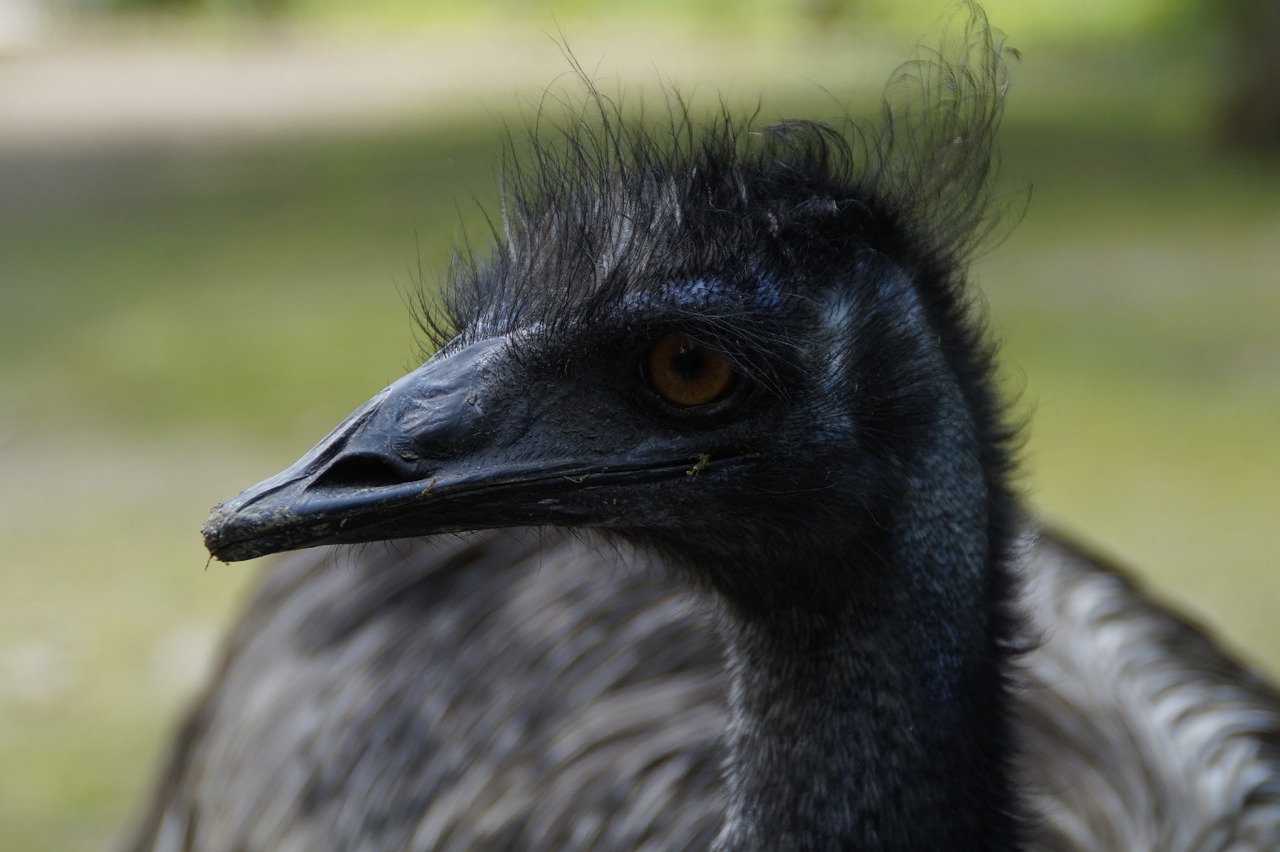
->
xmin=0 ymin=0 xmax=1280 ymax=849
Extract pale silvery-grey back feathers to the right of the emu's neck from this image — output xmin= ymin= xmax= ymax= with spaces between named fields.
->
xmin=1019 ymin=537 xmax=1280 ymax=852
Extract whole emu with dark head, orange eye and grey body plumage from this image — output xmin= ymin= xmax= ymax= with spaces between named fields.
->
xmin=129 ymin=5 xmax=1280 ymax=852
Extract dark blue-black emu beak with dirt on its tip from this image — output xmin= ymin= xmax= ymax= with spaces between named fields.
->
xmin=204 ymin=339 xmax=721 ymax=562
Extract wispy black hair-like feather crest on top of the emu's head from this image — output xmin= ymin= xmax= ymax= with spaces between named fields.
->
xmin=422 ymin=5 xmax=1007 ymax=347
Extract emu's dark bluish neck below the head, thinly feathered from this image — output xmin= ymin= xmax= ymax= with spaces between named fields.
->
xmin=716 ymin=409 xmax=1018 ymax=852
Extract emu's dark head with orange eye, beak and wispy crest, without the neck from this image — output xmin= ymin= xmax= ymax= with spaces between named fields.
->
xmin=205 ymin=14 xmax=1005 ymax=611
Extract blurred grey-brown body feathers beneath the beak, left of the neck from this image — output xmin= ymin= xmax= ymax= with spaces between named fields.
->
xmin=136 ymin=533 xmax=726 ymax=849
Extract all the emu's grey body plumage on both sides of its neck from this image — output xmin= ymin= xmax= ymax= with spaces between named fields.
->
xmin=136 ymin=528 xmax=1280 ymax=852
